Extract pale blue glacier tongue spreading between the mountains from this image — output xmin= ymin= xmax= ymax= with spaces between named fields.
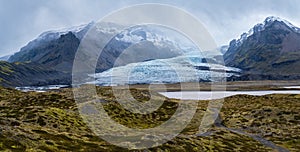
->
xmin=89 ymin=55 xmax=241 ymax=86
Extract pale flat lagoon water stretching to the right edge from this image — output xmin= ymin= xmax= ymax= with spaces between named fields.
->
xmin=160 ymin=90 xmax=300 ymax=100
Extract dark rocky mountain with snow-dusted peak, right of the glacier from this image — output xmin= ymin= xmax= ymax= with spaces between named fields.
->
xmin=224 ymin=17 xmax=300 ymax=80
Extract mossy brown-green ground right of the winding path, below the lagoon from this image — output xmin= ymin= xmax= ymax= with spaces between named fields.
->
xmin=221 ymin=94 xmax=300 ymax=151
